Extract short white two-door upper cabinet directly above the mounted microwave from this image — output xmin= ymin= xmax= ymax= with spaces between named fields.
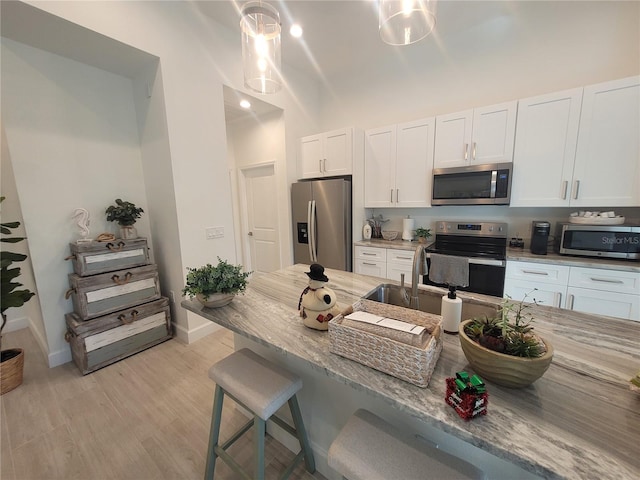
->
xmin=434 ymin=101 xmax=518 ymax=168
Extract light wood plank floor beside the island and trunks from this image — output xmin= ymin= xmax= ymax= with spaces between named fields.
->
xmin=0 ymin=329 xmax=324 ymax=480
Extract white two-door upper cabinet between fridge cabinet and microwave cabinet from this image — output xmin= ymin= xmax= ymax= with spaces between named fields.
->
xmin=364 ymin=117 xmax=435 ymax=208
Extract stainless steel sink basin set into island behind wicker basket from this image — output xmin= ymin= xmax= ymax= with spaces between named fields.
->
xmin=362 ymin=283 xmax=498 ymax=320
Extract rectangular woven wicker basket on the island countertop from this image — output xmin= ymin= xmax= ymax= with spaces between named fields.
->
xmin=329 ymin=300 xmax=442 ymax=388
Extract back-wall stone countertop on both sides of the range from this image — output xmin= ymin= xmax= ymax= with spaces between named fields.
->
xmin=354 ymin=238 xmax=640 ymax=273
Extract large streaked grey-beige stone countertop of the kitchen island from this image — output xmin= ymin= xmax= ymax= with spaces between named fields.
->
xmin=182 ymin=265 xmax=640 ymax=479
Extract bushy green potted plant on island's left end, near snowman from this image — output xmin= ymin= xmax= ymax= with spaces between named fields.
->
xmin=182 ymin=257 xmax=251 ymax=308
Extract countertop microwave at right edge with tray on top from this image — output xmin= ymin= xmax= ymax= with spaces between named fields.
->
xmin=555 ymin=223 xmax=640 ymax=260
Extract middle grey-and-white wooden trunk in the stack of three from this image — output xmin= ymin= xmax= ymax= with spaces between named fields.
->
xmin=69 ymin=265 xmax=160 ymax=320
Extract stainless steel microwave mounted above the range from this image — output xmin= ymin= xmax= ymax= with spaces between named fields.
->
xmin=431 ymin=163 xmax=513 ymax=205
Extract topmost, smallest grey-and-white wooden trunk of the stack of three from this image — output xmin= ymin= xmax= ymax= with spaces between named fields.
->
xmin=69 ymin=238 xmax=149 ymax=277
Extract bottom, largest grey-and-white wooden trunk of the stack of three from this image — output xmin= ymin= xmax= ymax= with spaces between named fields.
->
xmin=65 ymin=298 xmax=171 ymax=375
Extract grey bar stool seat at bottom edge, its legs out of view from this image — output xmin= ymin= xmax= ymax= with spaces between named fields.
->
xmin=328 ymin=409 xmax=486 ymax=480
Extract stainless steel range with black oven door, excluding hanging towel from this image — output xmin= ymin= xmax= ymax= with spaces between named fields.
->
xmin=423 ymin=221 xmax=507 ymax=297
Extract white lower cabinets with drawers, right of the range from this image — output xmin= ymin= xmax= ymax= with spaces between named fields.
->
xmin=504 ymin=261 xmax=640 ymax=321
